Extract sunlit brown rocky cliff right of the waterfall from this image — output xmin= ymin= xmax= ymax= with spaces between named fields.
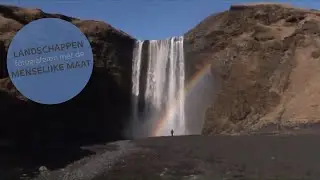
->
xmin=185 ymin=4 xmax=320 ymax=134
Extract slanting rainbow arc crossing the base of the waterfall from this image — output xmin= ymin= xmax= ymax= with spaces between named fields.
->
xmin=152 ymin=64 xmax=211 ymax=136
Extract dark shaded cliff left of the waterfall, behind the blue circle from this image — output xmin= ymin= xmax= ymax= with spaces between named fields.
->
xmin=0 ymin=6 xmax=135 ymax=148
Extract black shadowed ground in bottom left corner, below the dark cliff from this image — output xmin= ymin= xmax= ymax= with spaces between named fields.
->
xmin=0 ymin=147 xmax=93 ymax=180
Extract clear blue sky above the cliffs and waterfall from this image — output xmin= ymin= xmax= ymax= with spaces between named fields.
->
xmin=0 ymin=0 xmax=320 ymax=40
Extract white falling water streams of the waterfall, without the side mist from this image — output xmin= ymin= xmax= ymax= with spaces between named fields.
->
xmin=132 ymin=37 xmax=187 ymax=136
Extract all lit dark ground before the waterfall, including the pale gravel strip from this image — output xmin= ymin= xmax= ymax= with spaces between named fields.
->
xmin=3 ymin=127 xmax=320 ymax=180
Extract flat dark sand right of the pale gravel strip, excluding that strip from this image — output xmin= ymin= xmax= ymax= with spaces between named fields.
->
xmin=93 ymin=135 xmax=320 ymax=180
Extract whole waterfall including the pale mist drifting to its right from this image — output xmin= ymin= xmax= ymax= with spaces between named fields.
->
xmin=125 ymin=36 xmax=214 ymax=138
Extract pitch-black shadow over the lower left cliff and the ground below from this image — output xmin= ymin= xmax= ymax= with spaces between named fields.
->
xmin=0 ymin=72 xmax=160 ymax=180
